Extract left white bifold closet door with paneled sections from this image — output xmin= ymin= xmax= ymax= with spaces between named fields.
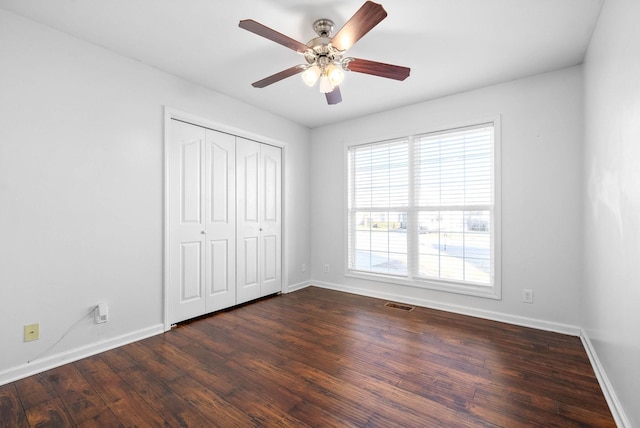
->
xmin=166 ymin=120 xmax=236 ymax=323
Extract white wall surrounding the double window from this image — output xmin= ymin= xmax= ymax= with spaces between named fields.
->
xmin=311 ymin=67 xmax=582 ymax=334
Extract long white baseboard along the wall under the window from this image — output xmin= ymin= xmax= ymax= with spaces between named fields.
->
xmin=311 ymin=281 xmax=580 ymax=337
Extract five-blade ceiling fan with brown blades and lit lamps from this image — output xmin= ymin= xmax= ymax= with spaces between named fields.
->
xmin=238 ymin=1 xmax=411 ymax=104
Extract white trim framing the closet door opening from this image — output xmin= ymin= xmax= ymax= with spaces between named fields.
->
xmin=163 ymin=106 xmax=288 ymax=331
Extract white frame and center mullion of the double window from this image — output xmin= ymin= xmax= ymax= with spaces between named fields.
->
xmin=343 ymin=116 xmax=502 ymax=300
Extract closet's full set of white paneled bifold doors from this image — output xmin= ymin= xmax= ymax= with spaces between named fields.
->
xmin=165 ymin=119 xmax=282 ymax=324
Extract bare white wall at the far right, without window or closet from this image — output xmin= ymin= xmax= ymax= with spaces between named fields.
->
xmin=581 ymin=0 xmax=640 ymax=427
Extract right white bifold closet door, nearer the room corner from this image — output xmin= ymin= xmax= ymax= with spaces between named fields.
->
xmin=236 ymin=137 xmax=282 ymax=303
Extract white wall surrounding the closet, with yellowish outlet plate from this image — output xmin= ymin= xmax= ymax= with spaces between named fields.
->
xmin=0 ymin=10 xmax=310 ymax=384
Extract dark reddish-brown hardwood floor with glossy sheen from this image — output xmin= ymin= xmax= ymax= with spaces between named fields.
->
xmin=0 ymin=287 xmax=615 ymax=427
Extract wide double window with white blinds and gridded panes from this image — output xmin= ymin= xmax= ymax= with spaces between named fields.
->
xmin=347 ymin=123 xmax=499 ymax=297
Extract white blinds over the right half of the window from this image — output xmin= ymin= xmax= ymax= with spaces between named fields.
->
xmin=413 ymin=126 xmax=494 ymax=285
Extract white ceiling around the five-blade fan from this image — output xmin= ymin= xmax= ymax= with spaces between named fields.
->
xmin=0 ymin=0 xmax=603 ymax=128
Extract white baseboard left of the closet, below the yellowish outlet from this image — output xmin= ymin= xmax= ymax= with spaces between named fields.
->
xmin=0 ymin=324 xmax=164 ymax=385
